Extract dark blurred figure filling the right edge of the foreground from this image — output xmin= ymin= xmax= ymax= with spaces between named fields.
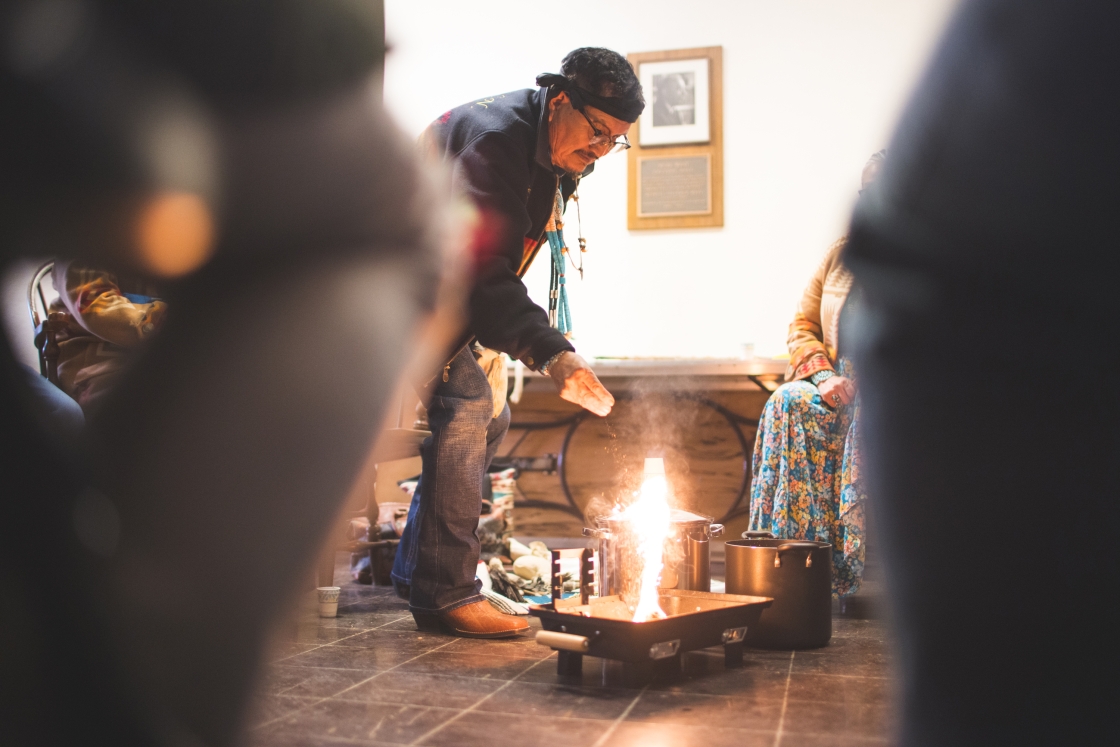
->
xmin=843 ymin=0 xmax=1120 ymax=747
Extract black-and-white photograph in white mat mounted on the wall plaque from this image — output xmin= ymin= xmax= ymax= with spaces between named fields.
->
xmin=638 ymin=57 xmax=711 ymax=148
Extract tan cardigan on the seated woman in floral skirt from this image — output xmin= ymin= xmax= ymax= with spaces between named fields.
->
xmin=785 ymin=236 xmax=851 ymax=381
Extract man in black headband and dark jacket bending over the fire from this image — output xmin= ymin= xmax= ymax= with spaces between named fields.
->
xmin=393 ymin=47 xmax=645 ymax=638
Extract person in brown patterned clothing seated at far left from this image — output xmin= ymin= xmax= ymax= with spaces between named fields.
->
xmin=50 ymin=262 xmax=167 ymax=411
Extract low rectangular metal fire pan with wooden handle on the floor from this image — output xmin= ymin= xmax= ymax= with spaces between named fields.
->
xmin=529 ymin=589 xmax=774 ymax=673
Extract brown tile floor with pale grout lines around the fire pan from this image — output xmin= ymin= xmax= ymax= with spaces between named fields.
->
xmin=251 ymin=555 xmax=893 ymax=747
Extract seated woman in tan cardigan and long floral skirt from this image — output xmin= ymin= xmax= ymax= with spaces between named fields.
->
xmin=750 ymin=150 xmax=886 ymax=597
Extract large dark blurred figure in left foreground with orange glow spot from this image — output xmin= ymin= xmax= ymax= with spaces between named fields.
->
xmin=0 ymin=0 xmax=454 ymax=747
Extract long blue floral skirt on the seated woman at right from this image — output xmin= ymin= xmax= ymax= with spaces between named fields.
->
xmin=750 ymin=365 xmax=865 ymax=597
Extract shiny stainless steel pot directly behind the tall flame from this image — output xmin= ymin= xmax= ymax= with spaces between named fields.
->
xmin=584 ymin=508 xmax=724 ymax=601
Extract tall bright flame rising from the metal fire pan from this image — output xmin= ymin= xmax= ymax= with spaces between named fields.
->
xmin=622 ymin=458 xmax=670 ymax=623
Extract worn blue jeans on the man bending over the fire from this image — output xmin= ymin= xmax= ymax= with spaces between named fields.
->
xmin=393 ymin=348 xmax=510 ymax=611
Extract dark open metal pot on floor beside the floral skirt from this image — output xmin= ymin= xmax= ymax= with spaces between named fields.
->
xmin=726 ymin=532 xmax=832 ymax=650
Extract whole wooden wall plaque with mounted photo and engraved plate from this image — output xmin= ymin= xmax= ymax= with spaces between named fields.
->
xmin=627 ymin=47 xmax=724 ymax=231
